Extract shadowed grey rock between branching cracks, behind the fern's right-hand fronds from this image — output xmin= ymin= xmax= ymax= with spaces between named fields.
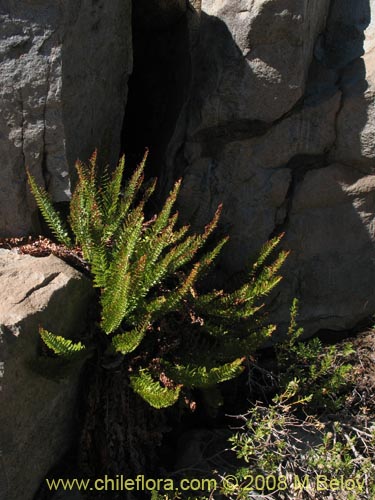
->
xmin=176 ymin=93 xmax=341 ymax=273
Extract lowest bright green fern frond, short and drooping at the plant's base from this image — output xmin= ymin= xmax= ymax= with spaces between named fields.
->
xmin=130 ymin=369 xmax=181 ymax=409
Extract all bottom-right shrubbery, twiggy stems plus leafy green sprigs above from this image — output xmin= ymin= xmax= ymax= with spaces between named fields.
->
xmin=222 ymin=301 xmax=375 ymax=500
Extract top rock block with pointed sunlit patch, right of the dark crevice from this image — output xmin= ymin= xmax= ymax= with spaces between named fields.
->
xmin=193 ymin=0 xmax=329 ymax=128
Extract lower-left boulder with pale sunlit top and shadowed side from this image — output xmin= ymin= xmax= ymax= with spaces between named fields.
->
xmin=0 ymin=250 xmax=92 ymax=500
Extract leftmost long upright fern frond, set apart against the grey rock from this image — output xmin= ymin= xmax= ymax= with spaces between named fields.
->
xmin=26 ymin=169 xmax=72 ymax=248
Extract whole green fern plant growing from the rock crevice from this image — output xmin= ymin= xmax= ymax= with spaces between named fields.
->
xmin=27 ymin=152 xmax=287 ymax=408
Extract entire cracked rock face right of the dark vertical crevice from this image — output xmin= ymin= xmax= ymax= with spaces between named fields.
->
xmin=159 ymin=0 xmax=375 ymax=333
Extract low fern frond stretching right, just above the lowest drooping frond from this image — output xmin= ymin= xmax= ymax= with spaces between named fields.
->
xmin=166 ymin=358 xmax=245 ymax=388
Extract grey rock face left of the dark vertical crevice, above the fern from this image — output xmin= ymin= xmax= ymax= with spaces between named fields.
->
xmin=0 ymin=0 xmax=132 ymax=236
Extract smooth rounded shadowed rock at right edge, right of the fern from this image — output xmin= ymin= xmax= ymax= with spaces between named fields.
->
xmin=284 ymin=164 xmax=375 ymax=333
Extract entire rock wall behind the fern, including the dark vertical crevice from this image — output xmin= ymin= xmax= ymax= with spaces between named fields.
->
xmin=0 ymin=0 xmax=375 ymax=333
